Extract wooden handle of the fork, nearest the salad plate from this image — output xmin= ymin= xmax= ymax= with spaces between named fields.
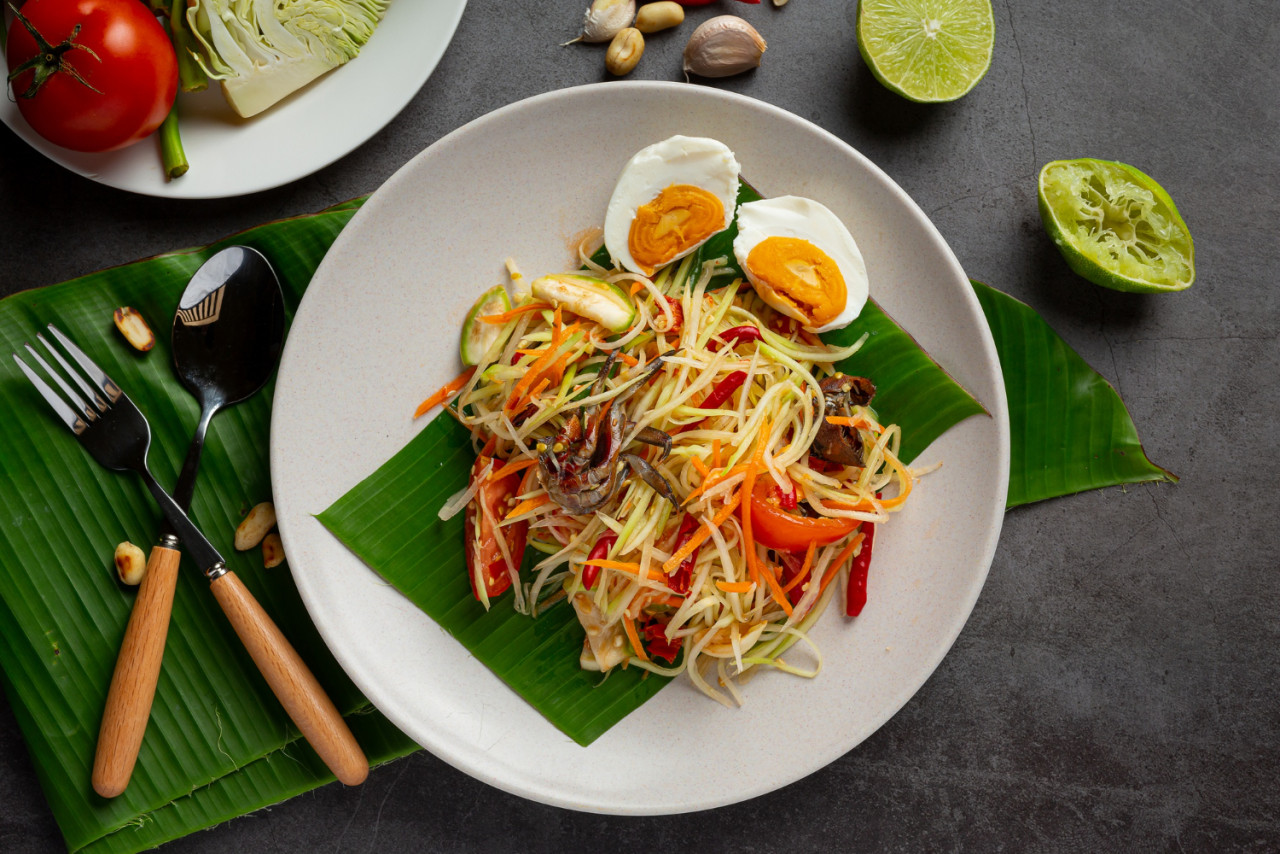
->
xmin=210 ymin=572 xmax=369 ymax=786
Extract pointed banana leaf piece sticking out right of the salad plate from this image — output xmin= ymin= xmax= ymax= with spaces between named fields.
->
xmin=973 ymin=282 xmax=1178 ymax=507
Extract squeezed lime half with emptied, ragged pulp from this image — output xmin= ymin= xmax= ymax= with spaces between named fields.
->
xmin=1039 ymin=157 xmax=1196 ymax=293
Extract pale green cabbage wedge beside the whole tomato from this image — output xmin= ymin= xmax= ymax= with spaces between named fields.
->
xmin=187 ymin=0 xmax=389 ymax=118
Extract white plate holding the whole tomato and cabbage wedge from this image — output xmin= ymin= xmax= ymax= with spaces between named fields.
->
xmin=0 ymin=0 xmax=466 ymax=198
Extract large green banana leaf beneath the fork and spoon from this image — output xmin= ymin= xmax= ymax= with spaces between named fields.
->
xmin=0 ymin=195 xmax=415 ymax=853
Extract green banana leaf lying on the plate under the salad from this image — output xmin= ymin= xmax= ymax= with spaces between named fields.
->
xmin=317 ymin=243 xmax=986 ymax=745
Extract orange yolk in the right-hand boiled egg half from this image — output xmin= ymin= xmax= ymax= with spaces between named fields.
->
xmin=746 ymin=237 xmax=847 ymax=326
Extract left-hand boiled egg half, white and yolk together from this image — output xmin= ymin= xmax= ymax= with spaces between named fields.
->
xmin=604 ymin=136 xmax=739 ymax=275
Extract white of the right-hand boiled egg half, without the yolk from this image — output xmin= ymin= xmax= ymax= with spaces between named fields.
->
xmin=733 ymin=196 xmax=869 ymax=332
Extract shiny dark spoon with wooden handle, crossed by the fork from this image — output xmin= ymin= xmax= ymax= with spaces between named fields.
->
xmin=92 ymin=246 xmax=284 ymax=798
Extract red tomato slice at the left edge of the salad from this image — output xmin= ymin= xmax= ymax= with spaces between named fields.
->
xmin=463 ymin=453 xmax=529 ymax=602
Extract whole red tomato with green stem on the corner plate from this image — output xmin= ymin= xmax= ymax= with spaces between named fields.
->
xmin=5 ymin=0 xmax=178 ymax=151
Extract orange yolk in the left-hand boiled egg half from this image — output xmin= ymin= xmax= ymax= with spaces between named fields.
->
xmin=627 ymin=184 xmax=724 ymax=275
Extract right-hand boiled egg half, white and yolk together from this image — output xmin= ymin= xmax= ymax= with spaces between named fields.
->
xmin=733 ymin=196 xmax=867 ymax=332
